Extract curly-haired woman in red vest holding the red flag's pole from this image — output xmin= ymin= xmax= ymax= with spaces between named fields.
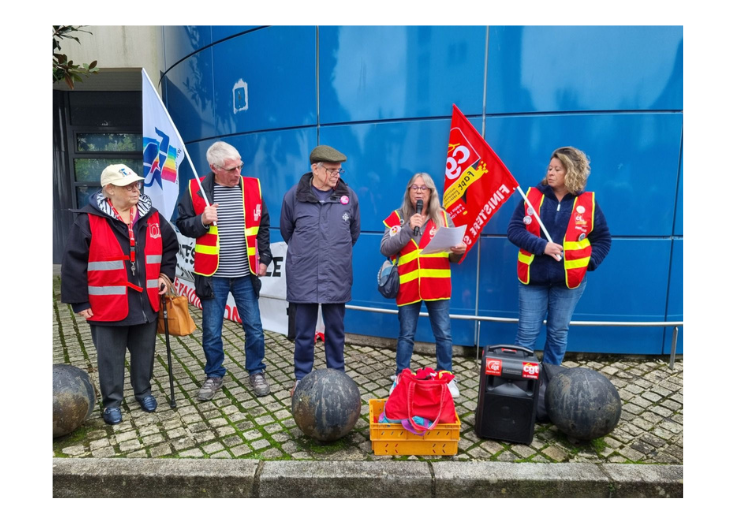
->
xmin=508 ymin=147 xmax=611 ymax=365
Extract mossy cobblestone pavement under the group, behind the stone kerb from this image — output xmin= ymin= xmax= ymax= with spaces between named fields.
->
xmin=53 ymin=276 xmax=683 ymax=464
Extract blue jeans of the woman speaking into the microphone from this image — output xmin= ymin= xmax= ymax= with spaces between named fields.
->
xmin=396 ymin=300 xmax=452 ymax=375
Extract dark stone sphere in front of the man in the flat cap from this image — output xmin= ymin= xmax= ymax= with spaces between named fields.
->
xmin=291 ymin=369 xmax=360 ymax=442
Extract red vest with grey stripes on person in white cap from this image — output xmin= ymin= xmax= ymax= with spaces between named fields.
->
xmin=87 ymin=212 xmax=163 ymax=322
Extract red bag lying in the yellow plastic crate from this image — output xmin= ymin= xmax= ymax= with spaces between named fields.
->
xmin=384 ymin=368 xmax=456 ymax=433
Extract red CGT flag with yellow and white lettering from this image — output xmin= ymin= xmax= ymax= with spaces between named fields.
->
xmin=443 ymin=104 xmax=519 ymax=262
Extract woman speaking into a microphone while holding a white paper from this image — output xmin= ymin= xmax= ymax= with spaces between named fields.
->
xmin=381 ymin=173 xmax=466 ymax=397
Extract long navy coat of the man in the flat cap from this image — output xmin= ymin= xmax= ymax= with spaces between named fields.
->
xmin=280 ymin=171 xmax=360 ymax=304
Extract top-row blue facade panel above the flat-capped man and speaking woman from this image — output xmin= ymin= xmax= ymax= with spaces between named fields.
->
xmin=319 ymin=26 xmax=486 ymax=124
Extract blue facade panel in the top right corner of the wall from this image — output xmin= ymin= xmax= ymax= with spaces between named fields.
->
xmin=486 ymin=26 xmax=683 ymax=114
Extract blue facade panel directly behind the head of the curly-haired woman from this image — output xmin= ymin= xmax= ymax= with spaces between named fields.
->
xmin=484 ymin=113 xmax=682 ymax=236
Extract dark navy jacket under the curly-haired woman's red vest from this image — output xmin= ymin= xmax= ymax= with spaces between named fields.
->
xmin=507 ymin=183 xmax=611 ymax=285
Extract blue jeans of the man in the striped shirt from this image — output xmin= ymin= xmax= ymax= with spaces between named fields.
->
xmin=202 ymin=276 xmax=266 ymax=377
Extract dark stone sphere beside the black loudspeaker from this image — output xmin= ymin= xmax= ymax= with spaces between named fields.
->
xmin=544 ymin=368 xmax=621 ymax=440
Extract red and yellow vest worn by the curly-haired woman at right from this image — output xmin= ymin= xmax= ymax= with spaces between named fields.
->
xmin=516 ymin=187 xmax=595 ymax=289
